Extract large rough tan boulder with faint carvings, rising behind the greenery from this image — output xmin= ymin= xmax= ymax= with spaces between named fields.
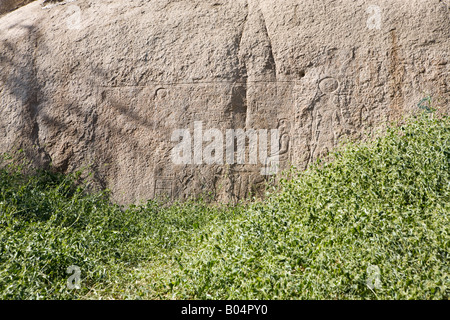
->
xmin=0 ymin=0 xmax=450 ymax=203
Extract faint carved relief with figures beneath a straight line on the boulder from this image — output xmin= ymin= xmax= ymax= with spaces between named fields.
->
xmin=94 ymin=75 xmax=358 ymax=201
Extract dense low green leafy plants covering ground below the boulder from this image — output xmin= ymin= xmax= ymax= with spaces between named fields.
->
xmin=0 ymin=113 xmax=450 ymax=299
